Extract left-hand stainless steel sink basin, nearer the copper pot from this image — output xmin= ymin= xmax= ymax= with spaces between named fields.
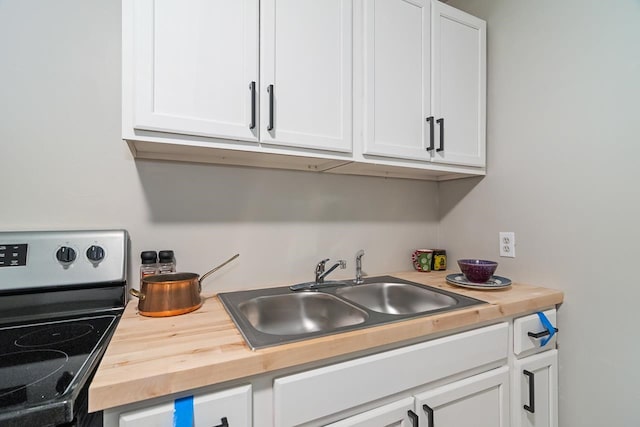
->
xmin=238 ymin=293 xmax=368 ymax=335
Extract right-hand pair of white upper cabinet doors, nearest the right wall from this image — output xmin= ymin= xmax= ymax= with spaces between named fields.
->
xmin=358 ymin=0 xmax=486 ymax=167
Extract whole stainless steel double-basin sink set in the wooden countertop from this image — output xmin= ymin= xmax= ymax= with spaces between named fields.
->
xmin=218 ymin=276 xmax=485 ymax=350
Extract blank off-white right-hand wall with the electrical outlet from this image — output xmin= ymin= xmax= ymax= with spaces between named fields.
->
xmin=439 ymin=0 xmax=640 ymax=427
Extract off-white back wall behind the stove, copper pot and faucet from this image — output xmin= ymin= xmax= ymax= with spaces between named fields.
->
xmin=0 ymin=0 xmax=438 ymax=292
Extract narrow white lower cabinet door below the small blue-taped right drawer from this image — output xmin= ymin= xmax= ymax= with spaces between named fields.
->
xmin=511 ymin=350 xmax=558 ymax=427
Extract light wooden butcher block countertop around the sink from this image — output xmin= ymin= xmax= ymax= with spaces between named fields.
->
xmin=89 ymin=271 xmax=563 ymax=412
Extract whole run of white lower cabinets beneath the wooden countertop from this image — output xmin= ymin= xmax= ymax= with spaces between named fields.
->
xmin=104 ymin=309 xmax=558 ymax=427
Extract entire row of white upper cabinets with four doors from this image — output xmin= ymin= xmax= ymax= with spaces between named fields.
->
xmin=122 ymin=0 xmax=486 ymax=180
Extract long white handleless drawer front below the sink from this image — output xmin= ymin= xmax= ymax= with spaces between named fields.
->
xmin=274 ymin=323 xmax=509 ymax=426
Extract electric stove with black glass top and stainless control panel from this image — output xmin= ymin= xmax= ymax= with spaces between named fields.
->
xmin=0 ymin=230 xmax=128 ymax=426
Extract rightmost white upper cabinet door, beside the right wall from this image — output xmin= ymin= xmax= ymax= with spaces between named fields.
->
xmin=431 ymin=1 xmax=486 ymax=166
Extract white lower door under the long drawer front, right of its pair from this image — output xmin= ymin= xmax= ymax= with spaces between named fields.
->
xmin=416 ymin=367 xmax=509 ymax=427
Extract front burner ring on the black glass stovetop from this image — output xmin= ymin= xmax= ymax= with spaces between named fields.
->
xmin=0 ymin=350 xmax=69 ymax=407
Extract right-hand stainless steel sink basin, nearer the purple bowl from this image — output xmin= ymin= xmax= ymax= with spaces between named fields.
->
xmin=336 ymin=282 xmax=458 ymax=314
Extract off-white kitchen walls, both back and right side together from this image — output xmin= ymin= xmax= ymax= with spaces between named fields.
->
xmin=6 ymin=0 xmax=640 ymax=427
